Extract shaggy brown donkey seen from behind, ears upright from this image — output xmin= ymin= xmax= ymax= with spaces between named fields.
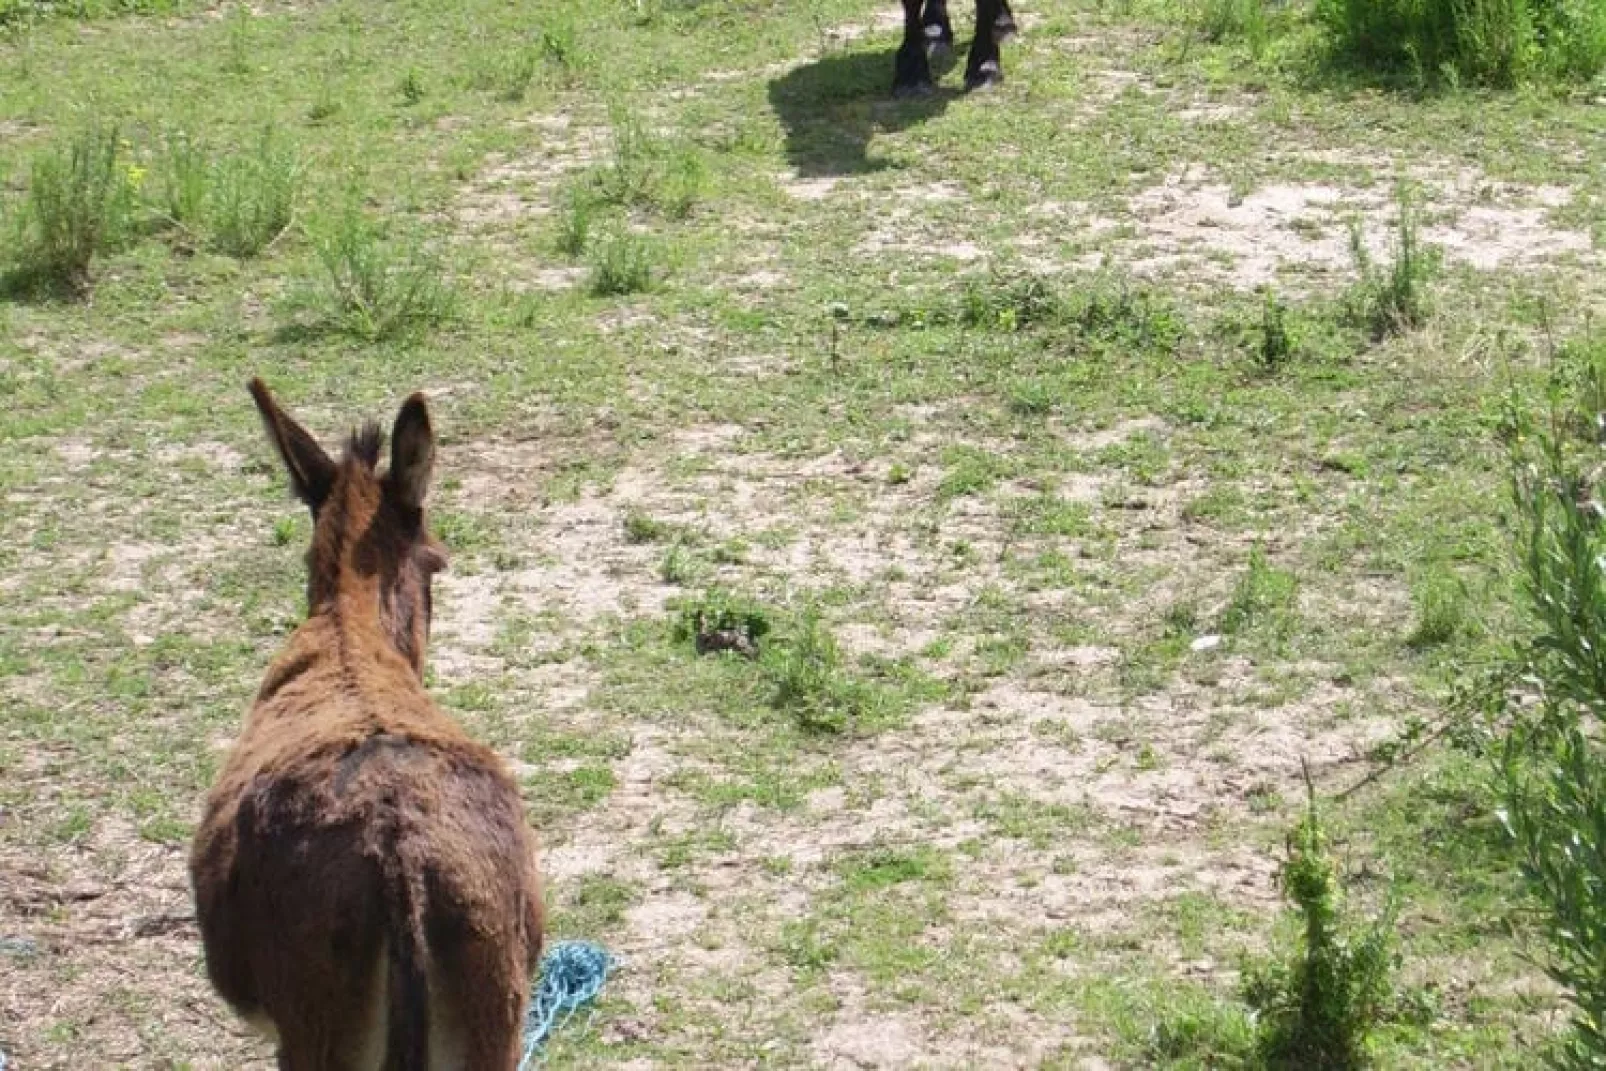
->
xmin=190 ymin=379 xmax=541 ymax=1071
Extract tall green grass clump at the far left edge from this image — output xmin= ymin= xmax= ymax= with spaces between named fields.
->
xmin=6 ymin=122 xmax=143 ymax=294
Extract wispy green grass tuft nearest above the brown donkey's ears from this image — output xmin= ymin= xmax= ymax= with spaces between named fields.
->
xmin=313 ymin=199 xmax=453 ymax=342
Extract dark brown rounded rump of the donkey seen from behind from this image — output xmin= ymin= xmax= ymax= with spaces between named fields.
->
xmin=196 ymin=732 xmax=540 ymax=1068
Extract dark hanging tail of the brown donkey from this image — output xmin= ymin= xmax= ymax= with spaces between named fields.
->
xmin=382 ymin=845 xmax=429 ymax=1071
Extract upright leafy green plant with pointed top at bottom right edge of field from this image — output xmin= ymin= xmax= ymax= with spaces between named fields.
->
xmin=1243 ymin=788 xmax=1396 ymax=1071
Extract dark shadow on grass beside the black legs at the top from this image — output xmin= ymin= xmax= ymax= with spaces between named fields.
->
xmin=769 ymin=50 xmax=959 ymax=177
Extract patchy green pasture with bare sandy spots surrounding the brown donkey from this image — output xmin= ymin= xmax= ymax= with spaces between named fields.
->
xmin=0 ymin=0 xmax=1606 ymax=1068
